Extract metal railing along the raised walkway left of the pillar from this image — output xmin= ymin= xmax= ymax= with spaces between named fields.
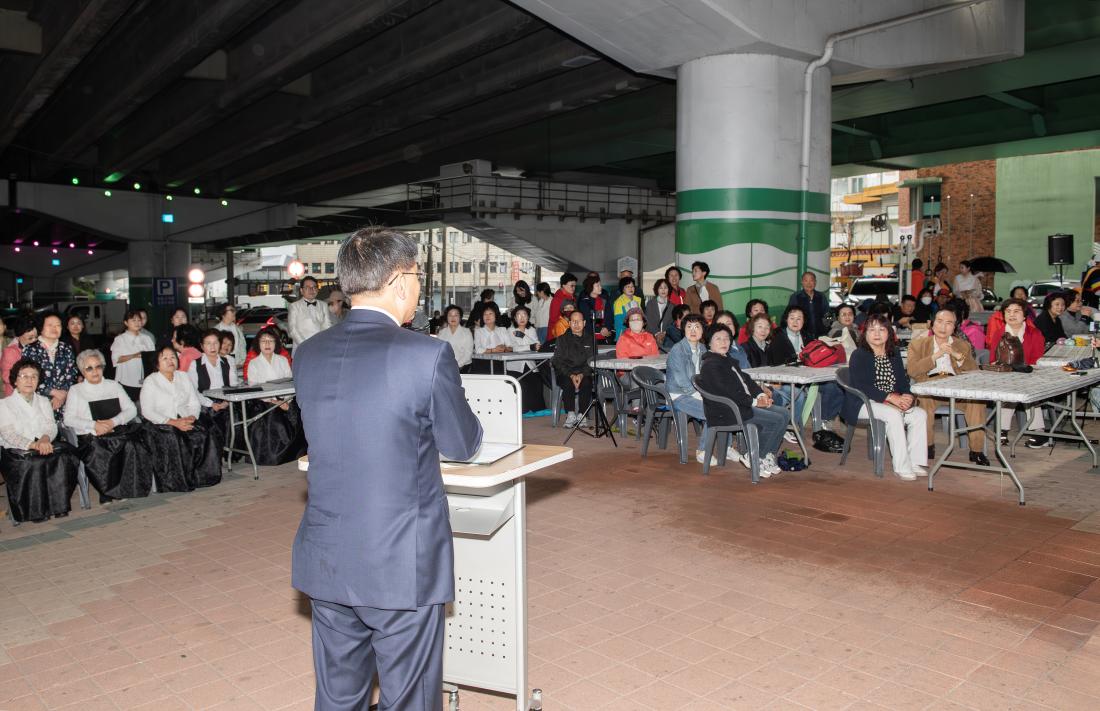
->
xmin=406 ymin=175 xmax=677 ymax=222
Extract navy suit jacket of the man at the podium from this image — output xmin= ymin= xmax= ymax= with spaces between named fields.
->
xmin=292 ymin=309 xmax=482 ymax=610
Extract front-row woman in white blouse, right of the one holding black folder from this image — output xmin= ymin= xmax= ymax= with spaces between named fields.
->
xmin=141 ymin=346 xmax=221 ymax=491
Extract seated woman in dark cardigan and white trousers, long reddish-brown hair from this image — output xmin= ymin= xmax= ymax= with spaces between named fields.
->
xmin=844 ymin=314 xmax=928 ymax=481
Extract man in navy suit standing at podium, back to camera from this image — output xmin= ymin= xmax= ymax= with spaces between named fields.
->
xmin=293 ymin=228 xmax=482 ymax=711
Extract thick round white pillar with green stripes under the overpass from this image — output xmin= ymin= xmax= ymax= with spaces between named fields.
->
xmin=677 ymin=54 xmax=831 ymax=318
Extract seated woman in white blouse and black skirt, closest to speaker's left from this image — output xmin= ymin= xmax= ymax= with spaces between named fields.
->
xmin=238 ymin=326 xmax=306 ymax=467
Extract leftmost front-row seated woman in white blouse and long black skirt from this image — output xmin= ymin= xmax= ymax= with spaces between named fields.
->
xmin=0 ymin=359 xmax=80 ymax=525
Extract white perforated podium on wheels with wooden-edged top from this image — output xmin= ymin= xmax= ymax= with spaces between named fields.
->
xmin=442 ymin=375 xmax=573 ymax=711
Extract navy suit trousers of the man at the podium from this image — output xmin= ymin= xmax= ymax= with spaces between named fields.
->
xmin=311 ymin=600 xmax=446 ymax=711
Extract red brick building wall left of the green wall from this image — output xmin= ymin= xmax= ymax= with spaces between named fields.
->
xmin=898 ymin=161 xmax=997 ymax=285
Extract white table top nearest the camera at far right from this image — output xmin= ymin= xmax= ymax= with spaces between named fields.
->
xmin=910 ymin=368 xmax=1100 ymax=404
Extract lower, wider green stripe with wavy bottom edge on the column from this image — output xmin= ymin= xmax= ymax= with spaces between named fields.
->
xmin=677 ymin=218 xmax=831 ymax=256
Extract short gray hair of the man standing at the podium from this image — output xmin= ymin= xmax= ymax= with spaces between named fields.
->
xmin=337 ymin=227 xmax=420 ymax=296
